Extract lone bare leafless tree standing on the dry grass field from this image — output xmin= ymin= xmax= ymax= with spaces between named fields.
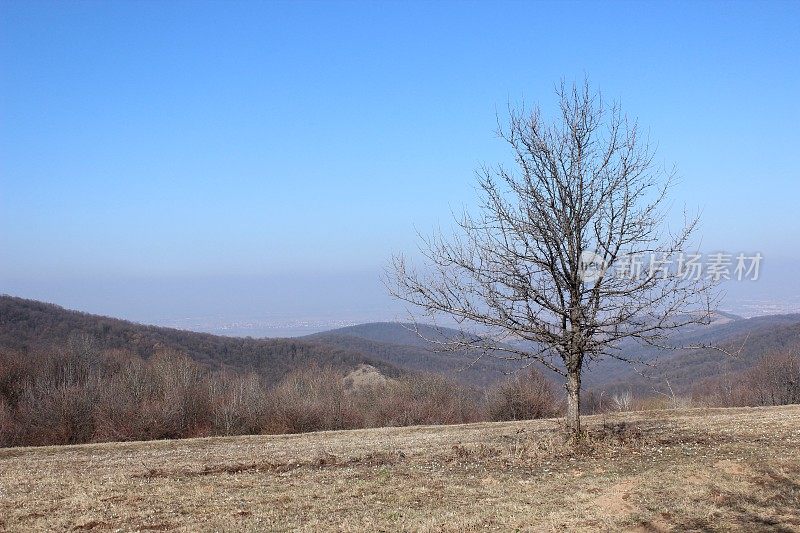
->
xmin=388 ymin=82 xmax=713 ymax=439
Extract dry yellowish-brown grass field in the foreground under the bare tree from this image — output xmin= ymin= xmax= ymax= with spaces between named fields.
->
xmin=0 ymin=406 xmax=800 ymax=532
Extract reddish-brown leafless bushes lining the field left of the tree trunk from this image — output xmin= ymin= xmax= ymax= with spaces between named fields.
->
xmin=0 ymin=335 xmax=557 ymax=446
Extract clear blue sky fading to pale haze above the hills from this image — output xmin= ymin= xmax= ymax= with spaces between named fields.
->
xmin=0 ymin=1 xmax=800 ymax=321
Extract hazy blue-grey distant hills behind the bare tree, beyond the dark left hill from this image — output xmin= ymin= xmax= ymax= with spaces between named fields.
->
xmin=316 ymin=313 xmax=800 ymax=395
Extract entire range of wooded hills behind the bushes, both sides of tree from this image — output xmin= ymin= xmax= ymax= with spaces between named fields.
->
xmin=0 ymin=296 xmax=800 ymax=393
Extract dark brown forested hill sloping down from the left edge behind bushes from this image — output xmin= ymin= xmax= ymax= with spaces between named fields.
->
xmin=0 ymin=296 xmax=402 ymax=382
